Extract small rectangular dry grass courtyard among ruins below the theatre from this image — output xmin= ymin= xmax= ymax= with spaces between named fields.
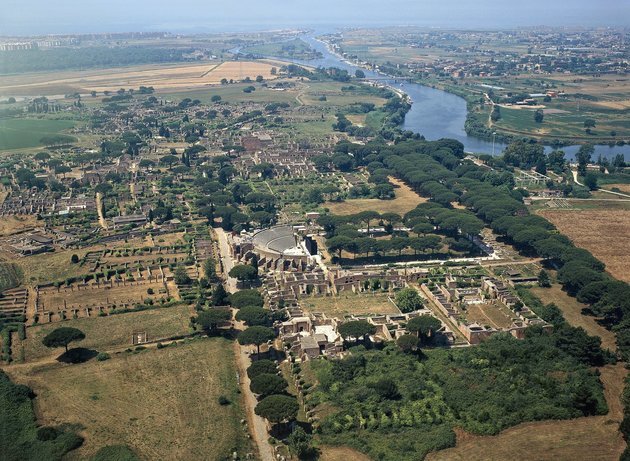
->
xmin=301 ymin=291 xmax=400 ymax=318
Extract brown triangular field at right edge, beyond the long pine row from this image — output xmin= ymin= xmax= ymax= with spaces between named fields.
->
xmin=538 ymin=206 xmax=630 ymax=282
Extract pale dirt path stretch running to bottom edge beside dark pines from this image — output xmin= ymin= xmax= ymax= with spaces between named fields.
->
xmin=234 ymin=341 xmax=274 ymax=461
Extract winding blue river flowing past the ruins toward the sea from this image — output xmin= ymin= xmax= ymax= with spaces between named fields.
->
xmin=254 ymin=35 xmax=630 ymax=160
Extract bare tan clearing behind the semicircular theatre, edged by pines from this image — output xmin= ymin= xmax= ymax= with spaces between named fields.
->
xmin=324 ymin=177 xmax=428 ymax=215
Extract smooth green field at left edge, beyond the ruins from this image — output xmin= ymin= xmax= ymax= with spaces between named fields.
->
xmin=0 ymin=118 xmax=75 ymax=150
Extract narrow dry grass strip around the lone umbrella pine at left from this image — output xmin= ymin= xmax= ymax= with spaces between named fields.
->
xmin=14 ymin=306 xmax=192 ymax=362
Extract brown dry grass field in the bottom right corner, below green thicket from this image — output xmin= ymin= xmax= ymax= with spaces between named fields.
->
xmin=426 ymin=363 xmax=627 ymax=461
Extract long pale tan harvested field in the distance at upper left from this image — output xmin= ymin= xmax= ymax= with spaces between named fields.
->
xmin=0 ymin=60 xmax=281 ymax=95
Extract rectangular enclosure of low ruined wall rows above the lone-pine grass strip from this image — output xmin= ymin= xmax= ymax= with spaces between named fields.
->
xmin=36 ymin=270 xmax=180 ymax=323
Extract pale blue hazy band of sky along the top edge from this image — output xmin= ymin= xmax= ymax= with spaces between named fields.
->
xmin=0 ymin=0 xmax=630 ymax=35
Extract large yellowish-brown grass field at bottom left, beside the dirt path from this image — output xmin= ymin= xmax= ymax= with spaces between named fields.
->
xmin=7 ymin=338 xmax=252 ymax=460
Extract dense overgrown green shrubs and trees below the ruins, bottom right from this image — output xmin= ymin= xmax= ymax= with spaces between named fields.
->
xmin=314 ymin=330 xmax=607 ymax=460
